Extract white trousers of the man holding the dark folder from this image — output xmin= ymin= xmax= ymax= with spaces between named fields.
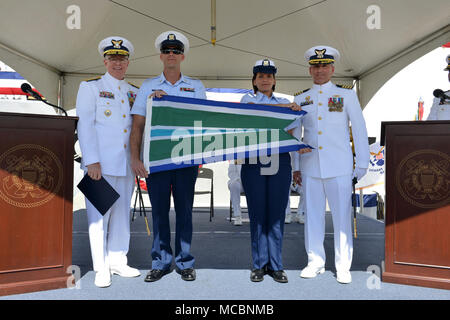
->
xmin=86 ymin=170 xmax=134 ymax=272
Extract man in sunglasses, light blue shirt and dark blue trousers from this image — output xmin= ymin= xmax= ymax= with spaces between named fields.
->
xmin=130 ymin=31 xmax=206 ymax=282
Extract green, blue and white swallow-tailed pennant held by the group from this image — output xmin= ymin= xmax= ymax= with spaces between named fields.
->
xmin=143 ymin=95 xmax=308 ymax=173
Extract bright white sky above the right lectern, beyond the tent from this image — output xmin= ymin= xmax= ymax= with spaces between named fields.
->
xmin=363 ymin=47 xmax=450 ymax=141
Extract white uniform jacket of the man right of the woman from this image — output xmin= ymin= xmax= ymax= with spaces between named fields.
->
xmin=294 ymin=82 xmax=370 ymax=179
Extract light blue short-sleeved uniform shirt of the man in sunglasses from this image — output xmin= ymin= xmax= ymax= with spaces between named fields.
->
xmin=130 ymin=73 xmax=206 ymax=117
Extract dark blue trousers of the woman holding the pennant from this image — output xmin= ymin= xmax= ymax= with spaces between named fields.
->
xmin=241 ymin=153 xmax=292 ymax=271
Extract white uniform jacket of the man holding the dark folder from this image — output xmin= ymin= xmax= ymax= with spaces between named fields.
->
xmin=76 ymin=73 xmax=138 ymax=176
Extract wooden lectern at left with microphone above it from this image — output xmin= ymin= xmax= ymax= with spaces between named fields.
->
xmin=0 ymin=112 xmax=78 ymax=296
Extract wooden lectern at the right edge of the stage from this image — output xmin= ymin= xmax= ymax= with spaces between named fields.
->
xmin=381 ymin=121 xmax=450 ymax=289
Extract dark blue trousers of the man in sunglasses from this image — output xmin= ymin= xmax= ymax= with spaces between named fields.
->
xmin=146 ymin=166 xmax=198 ymax=270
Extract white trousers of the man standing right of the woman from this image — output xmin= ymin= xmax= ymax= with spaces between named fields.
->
xmin=302 ymin=175 xmax=353 ymax=272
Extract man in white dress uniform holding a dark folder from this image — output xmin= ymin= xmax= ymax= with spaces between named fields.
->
xmin=76 ymin=36 xmax=140 ymax=287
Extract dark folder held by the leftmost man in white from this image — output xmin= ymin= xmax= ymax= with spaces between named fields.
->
xmin=77 ymin=174 xmax=120 ymax=215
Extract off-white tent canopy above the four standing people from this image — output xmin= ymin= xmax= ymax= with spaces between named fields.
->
xmin=0 ymin=0 xmax=450 ymax=109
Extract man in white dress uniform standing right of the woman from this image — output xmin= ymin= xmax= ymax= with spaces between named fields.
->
xmin=294 ymin=46 xmax=369 ymax=283
